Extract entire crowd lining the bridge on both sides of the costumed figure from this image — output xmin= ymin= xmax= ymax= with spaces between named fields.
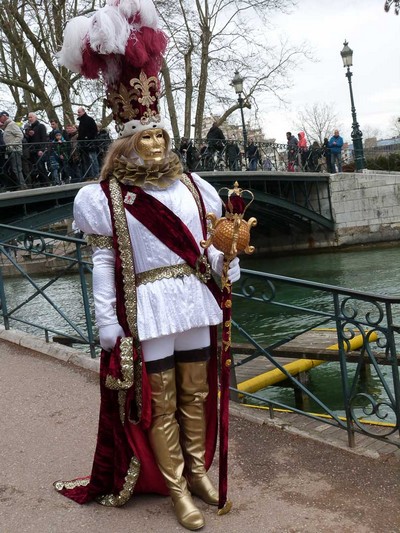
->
xmin=0 ymin=107 xmax=343 ymax=190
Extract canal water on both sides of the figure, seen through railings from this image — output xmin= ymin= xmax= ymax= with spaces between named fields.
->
xmin=5 ymin=245 xmax=400 ymax=420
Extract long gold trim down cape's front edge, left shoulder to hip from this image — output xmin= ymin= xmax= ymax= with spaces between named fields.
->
xmin=110 ymin=177 xmax=138 ymax=339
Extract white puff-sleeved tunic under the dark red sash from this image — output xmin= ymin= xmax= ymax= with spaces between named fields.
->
xmin=74 ymin=174 xmax=222 ymax=341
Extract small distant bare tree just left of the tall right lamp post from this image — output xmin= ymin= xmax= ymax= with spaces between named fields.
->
xmin=297 ymin=104 xmax=341 ymax=146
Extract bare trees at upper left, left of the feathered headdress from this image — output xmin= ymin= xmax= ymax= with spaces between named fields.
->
xmin=0 ymin=0 xmax=103 ymax=122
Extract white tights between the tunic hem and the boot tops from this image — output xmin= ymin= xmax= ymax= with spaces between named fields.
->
xmin=142 ymin=326 xmax=210 ymax=363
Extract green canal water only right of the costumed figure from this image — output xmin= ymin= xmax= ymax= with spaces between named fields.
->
xmin=233 ymin=245 xmax=400 ymax=421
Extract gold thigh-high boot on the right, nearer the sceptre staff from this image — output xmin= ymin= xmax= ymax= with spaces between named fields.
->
xmin=175 ymin=347 xmax=218 ymax=505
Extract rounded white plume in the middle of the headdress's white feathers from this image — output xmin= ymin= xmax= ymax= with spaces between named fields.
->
xmin=89 ymin=6 xmax=130 ymax=55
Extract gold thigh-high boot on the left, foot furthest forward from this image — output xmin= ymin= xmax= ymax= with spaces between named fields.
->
xmin=146 ymin=356 xmax=204 ymax=531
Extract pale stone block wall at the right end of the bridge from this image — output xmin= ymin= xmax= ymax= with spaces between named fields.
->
xmin=330 ymin=170 xmax=400 ymax=246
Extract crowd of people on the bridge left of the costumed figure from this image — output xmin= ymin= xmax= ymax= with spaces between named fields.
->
xmin=0 ymin=107 xmax=112 ymax=190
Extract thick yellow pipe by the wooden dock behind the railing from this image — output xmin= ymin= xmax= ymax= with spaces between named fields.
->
xmin=237 ymin=332 xmax=378 ymax=393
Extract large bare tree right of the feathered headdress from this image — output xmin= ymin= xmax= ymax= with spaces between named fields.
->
xmin=157 ymin=0 xmax=308 ymax=139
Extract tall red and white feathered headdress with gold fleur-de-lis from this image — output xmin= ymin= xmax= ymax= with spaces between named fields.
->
xmin=58 ymin=0 xmax=167 ymax=137
